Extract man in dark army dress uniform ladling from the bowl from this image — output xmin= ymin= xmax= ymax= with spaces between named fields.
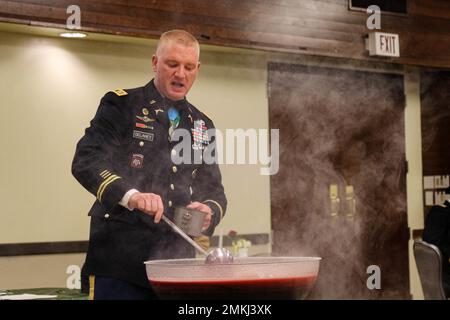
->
xmin=72 ymin=30 xmax=227 ymax=299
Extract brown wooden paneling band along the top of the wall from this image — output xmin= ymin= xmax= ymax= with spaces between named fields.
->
xmin=0 ymin=0 xmax=450 ymax=68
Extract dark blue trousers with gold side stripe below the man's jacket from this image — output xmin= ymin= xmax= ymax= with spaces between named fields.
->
xmin=89 ymin=276 xmax=157 ymax=300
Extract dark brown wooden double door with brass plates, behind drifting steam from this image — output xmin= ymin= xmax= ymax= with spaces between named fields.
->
xmin=269 ymin=64 xmax=410 ymax=299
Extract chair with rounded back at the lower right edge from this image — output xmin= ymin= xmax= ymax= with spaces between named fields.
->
xmin=413 ymin=240 xmax=446 ymax=300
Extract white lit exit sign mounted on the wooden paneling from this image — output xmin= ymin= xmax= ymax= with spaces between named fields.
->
xmin=367 ymin=32 xmax=400 ymax=57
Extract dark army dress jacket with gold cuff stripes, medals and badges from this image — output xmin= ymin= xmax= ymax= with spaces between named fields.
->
xmin=72 ymin=80 xmax=227 ymax=287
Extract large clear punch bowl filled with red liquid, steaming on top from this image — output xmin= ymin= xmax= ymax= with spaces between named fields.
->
xmin=145 ymin=257 xmax=321 ymax=300
